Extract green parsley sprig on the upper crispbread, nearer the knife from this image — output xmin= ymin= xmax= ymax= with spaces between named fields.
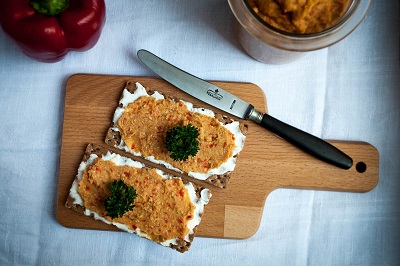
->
xmin=165 ymin=124 xmax=200 ymax=161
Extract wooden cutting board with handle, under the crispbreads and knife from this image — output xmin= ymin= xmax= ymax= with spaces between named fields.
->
xmin=57 ymin=74 xmax=379 ymax=239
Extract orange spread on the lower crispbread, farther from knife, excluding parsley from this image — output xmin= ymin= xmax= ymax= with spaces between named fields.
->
xmin=78 ymin=158 xmax=195 ymax=242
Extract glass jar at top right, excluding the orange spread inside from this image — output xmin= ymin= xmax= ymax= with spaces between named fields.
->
xmin=228 ymin=0 xmax=371 ymax=64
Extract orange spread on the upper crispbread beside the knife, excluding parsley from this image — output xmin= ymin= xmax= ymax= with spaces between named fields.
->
xmin=117 ymin=96 xmax=236 ymax=173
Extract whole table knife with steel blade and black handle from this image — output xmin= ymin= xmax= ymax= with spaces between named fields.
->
xmin=137 ymin=49 xmax=353 ymax=169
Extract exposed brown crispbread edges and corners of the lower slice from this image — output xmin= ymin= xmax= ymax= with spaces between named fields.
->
xmin=65 ymin=144 xmax=211 ymax=253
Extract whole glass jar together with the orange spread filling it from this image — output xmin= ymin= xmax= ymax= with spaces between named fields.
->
xmin=228 ymin=0 xmax=371 ymax=64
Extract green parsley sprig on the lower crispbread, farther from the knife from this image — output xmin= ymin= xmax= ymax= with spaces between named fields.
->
xmin=104 ymin=180 xmax=136 ymax=219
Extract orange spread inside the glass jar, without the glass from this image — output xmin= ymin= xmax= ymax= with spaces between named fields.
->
xmin=247 ymin=0 xmax=351 ymax=34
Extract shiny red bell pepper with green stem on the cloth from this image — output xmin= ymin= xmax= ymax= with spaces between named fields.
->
xmin=0 ymin=0 xmax=106 ymax=62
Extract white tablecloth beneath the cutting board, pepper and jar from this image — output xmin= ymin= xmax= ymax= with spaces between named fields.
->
xmin=0 ymin=0 xmax=400 ymax=265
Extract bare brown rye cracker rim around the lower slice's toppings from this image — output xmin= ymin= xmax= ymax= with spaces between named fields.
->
xmin=65 ymin=144 xmax=211 ymax=253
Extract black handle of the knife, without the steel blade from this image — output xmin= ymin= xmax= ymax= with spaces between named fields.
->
xmin=259 ymin=114 xmax=353 ymax=169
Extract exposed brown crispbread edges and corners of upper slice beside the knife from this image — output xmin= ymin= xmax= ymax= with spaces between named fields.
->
xmin=105 ymin=82 xmax=248 ymax=188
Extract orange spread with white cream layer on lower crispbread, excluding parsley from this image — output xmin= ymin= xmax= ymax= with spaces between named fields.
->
xmin=70 ymin=152 xmax=211 ymax=246
